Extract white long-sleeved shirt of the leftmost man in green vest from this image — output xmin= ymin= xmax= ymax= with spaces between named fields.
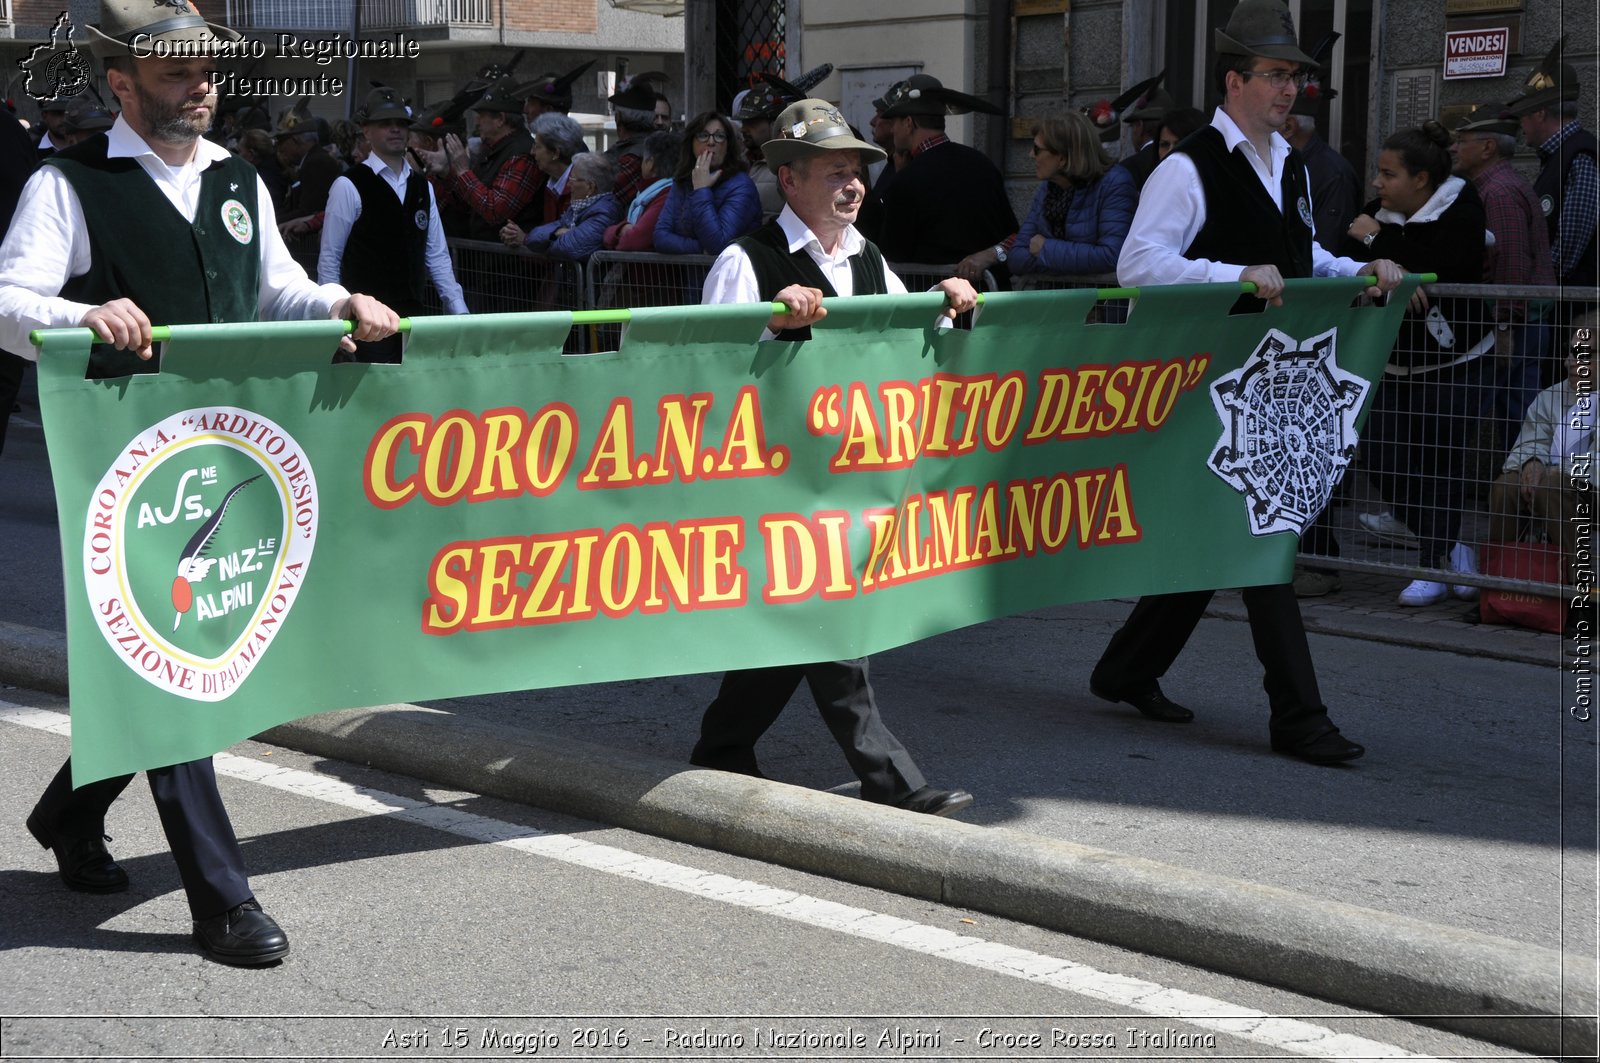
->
xmin=0 ymin=115 xmax=349 ymax=359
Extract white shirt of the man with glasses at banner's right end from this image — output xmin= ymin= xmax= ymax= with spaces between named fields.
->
xmin=1117 ymin=107 xmax=1366 ymax=287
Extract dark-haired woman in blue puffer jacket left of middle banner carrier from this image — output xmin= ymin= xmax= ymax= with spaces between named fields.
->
xmin=656 ymin=110 xmax=762 ymax=255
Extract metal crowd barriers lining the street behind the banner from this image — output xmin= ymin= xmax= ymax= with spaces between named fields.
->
xmin=425 ymin=246 xmax=1597 ymax=597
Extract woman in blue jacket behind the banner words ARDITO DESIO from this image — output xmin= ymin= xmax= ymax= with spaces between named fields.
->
xmin=1006 ymin=110 xmax=1139 ymax=277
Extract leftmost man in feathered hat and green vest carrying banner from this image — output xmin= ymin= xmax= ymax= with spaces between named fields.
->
xmin=0 ymin=0 xmax=397 ymax=964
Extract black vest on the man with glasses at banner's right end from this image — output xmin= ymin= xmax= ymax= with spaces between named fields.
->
xmin=1173 ymin=125 xmax=1312 ymax=277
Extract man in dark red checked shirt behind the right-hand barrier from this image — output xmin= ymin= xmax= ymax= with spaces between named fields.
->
xmin=1450 ymin=107 xmax=1555 ymax=445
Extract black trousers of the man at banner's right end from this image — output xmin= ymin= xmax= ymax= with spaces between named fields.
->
xmin=1091 ymin=583 xmax=1331 ymax=740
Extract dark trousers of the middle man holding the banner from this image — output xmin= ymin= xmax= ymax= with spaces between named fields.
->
xmin=693 ymin=656 xmax=926 ymax=800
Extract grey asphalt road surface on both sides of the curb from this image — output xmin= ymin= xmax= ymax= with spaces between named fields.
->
xmin=0 ymin=377 xmax=1595 ymax=1058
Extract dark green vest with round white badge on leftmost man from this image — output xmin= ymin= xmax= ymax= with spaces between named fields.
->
xmin=45 ymin=136 xmax=261 ymax=379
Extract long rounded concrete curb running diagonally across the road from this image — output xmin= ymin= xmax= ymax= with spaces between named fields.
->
xmin=0 ymin=624 xmax=1597 ymax=1055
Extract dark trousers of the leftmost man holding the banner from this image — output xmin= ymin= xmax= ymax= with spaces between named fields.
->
xmin=27 ymin=757 xmax=251 ymax=919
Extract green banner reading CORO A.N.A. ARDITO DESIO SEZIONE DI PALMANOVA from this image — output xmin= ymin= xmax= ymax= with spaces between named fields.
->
xmin=40 ymin=280 xmax=1410 ymax=783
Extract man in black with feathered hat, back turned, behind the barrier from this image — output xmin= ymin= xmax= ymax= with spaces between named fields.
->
xmin=867 ymin=74 xmax=1018 ymax=284
